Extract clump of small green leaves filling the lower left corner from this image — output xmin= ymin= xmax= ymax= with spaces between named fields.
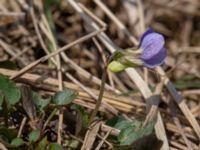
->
xmin=0 ymin=75 xmax=77 ymax=150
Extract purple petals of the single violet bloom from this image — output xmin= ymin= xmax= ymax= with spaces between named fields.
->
xmin=139 ymin=29 xmax=166 ymax=68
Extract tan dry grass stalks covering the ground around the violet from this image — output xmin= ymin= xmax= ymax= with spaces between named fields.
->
xmin=0 ymin=0 xmax=200 ymax=150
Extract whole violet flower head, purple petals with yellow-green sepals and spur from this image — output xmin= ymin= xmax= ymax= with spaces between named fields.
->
xmin=108 ymin=29 xmax=167 ymax=72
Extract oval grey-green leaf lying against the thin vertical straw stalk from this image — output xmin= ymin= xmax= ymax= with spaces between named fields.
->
xmin=52 ymin=90 xmax=78 ymax=105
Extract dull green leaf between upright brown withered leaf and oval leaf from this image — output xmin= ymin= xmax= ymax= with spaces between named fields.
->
xmin=32 ymin=92 xmax=51 ymax=112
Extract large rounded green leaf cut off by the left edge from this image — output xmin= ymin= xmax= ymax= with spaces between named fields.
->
xmin=0 ymin=75 xmax=21 ymax=105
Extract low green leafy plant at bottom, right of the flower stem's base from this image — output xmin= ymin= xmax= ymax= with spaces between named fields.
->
xmin=106 ymin=116 xmax=162 ymax=150
